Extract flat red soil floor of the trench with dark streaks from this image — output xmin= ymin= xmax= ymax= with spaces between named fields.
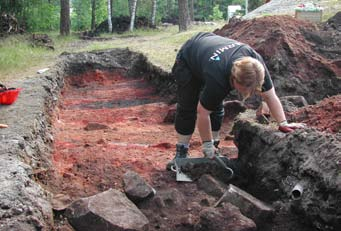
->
xmin=47 ymin=71 xmax=234 ymax=199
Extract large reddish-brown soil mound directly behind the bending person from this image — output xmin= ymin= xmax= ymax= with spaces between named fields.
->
xmin=214 ymin=16 xmax=341 ymax=104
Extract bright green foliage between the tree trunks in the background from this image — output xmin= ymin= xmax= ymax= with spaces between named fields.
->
xmin=0 ymin=0 xmax=265 ymax=32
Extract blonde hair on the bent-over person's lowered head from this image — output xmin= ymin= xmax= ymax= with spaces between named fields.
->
xmin=230 ymin=57 xmax=265 ymax=100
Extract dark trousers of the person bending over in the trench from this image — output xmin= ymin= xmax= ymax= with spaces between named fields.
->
xmin=172 ymin=51 xmax=224 ymax=135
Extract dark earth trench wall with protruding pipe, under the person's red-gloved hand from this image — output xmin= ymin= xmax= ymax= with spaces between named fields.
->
xmin=233 ymin=111 xmax=341 ymax=230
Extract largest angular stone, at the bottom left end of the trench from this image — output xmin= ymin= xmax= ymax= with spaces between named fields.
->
xmin=65 ymin=189 xmax=149 ymax=231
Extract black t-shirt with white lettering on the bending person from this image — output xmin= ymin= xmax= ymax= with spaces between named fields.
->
xmin=182 ymin=32 xmax=273 ymax=111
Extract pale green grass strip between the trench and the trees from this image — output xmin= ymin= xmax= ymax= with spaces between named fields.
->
xmin=0 ymin=22 xmax=224 ymax=83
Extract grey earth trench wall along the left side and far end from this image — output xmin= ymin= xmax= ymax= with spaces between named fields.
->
xmin=0 ymin=49 xmax=174 ymax=231
